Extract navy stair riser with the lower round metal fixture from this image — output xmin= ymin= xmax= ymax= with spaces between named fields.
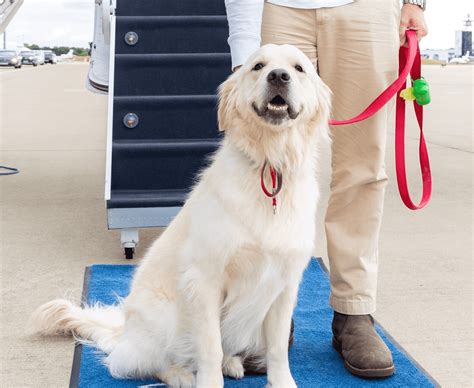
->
xmin=113 ymin=95 xmax=219 ymax=140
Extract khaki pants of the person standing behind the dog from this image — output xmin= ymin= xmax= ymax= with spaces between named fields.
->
xmin=262 ymin=0 xmax=400 ymax=314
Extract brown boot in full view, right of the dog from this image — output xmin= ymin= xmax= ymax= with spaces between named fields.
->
xmin=332 ymin=312 xmax=395 ymax=378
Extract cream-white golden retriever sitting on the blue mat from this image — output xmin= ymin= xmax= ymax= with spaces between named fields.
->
xmin=32 ymin=45 xmax=330 ymax=388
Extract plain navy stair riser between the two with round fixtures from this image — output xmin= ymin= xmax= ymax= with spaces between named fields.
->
xmin=114 ymin=53 xmax=231 ymax=96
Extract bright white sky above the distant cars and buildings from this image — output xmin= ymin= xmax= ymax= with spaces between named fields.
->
xmin=2 ymin=0 xmax=474 ymax=49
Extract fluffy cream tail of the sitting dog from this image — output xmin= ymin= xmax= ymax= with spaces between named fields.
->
xmin=30 ymin=299 xmax=125 ymax=353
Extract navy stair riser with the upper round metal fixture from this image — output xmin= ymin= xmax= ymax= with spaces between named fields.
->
xmin=115 ymin=16 xmax=229 ymax=54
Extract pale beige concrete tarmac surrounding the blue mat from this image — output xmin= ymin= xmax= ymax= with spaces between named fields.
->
xmin=0 ymin=63 xmax=474 ymax=388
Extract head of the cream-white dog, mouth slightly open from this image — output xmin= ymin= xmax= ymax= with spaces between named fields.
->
xmin=218 ymin=44 xmax=330 ymax=136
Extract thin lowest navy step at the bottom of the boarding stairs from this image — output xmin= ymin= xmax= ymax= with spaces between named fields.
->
xmin=107 ymin=189 xmax=189 ymax=208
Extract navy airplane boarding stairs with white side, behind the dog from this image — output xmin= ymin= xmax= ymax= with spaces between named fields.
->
xmin=106 ymin=0 xmax=231 ymax=258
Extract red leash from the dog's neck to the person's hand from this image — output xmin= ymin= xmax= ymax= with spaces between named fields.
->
xmin=260 ymin=30 xmax=431 ymax=212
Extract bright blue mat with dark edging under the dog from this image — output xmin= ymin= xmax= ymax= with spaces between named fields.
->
xmin=71 ymin=260 xmax=439 ymax=388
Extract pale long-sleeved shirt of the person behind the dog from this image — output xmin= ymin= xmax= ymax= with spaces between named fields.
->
xmin=225 ymin=0 xmax=353 ymax=69
